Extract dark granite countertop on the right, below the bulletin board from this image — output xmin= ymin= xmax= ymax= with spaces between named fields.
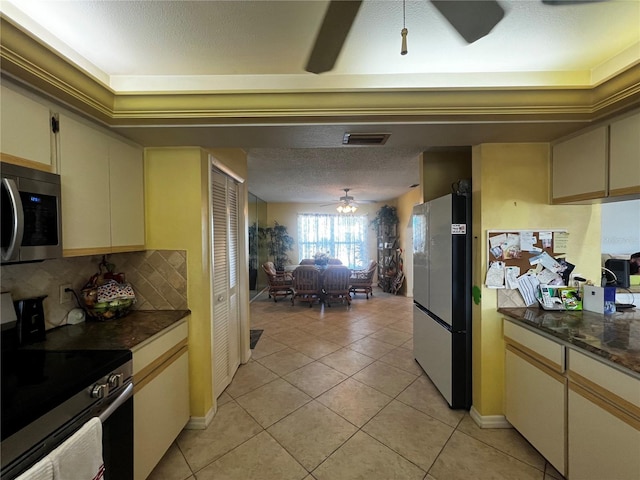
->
xmin=498 ymin=307 xmax=640 ymax=376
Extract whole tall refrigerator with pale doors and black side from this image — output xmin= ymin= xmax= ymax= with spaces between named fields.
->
xmin=412 ymin=192 xmax=472 ymax=409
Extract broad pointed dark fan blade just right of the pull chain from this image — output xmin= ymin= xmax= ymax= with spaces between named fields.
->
xmin=431 ymin=0 xmax=504 ymax=43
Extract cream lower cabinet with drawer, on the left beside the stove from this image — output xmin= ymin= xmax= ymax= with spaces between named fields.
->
xmin=133 ymin=319 xmax=189 ymax=480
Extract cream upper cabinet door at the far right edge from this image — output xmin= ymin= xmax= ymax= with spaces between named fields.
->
xmin=609 ymin=113 xmax=640 ymax=196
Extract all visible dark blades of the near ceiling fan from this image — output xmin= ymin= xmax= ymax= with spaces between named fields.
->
xmin=305 ymin=0 xmax=601 ymax=73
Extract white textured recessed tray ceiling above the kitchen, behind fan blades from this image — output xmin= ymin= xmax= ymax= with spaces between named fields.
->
xmin=2 ymin=0 xmax=640 ymax=90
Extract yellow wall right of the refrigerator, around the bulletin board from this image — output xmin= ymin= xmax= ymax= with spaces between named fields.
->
xmin=472 ymin=143 xmax=600 ymax=416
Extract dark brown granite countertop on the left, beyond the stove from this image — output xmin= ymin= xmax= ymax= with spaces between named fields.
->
xmin=29 ymin=310 xmax=191 ymax=350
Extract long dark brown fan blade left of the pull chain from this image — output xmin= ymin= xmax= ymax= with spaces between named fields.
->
xmin=305 ymin=0 xmax=362 ymax=73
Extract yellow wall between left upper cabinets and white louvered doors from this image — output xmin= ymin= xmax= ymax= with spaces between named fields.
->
xmin=145 ymin=148 xmax=213 ymax=417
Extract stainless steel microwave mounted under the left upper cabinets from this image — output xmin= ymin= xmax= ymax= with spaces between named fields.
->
xmin=0 ymin=163 xmax=62 ymax=265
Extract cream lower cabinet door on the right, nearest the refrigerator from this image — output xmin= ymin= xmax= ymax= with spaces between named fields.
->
xmin=505 ymin=345 xmax=566 ymax=473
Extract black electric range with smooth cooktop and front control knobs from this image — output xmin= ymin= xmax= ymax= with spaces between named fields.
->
xmin=0 ymin=332 xmax=133 ymax=479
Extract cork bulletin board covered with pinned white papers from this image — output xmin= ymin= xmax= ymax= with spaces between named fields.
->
xmin=485 ymin=230 xmax=573 ymax=305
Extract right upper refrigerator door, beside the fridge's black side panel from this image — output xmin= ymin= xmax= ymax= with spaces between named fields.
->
xmin=427 ymin=195 xmax=453 ymax=325
